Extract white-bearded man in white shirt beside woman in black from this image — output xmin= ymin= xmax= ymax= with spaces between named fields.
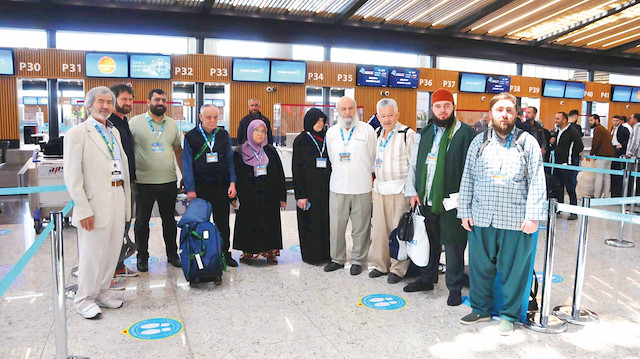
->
xmin=324 ymin=96 xmax=376 ymax=275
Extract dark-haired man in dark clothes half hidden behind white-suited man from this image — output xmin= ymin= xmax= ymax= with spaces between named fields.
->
xmin=109 ymin=84 xmax=138 ymax=290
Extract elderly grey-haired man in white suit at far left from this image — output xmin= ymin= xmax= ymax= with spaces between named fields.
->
xmin=64 ymin=86 xmax=131 ymax=319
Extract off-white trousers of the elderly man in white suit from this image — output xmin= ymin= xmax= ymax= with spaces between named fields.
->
xmin=73 ymin=187 xmax=126 ymax=310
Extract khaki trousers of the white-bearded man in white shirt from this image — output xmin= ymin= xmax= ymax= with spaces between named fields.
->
xmin=329 ymin=191 xmax=372 ymax=267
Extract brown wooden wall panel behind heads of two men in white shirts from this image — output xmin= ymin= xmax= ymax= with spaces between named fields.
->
xmin=355 ymin=86 xmax=418 ymax=130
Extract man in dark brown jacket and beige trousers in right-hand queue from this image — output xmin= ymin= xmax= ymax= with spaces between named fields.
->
xmin=586 ymin=114 xmax=613 ymax=198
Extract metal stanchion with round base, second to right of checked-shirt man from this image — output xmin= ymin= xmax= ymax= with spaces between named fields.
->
xmin=553 ymin=197 xmax=599 ymax=325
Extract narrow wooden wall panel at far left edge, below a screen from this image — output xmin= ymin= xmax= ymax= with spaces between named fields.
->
xmin=0 ymin=76 xmax=20 ymax=140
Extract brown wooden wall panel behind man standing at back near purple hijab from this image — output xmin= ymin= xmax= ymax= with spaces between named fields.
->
xmin=229 ymin=82 xmax=306 ymax=137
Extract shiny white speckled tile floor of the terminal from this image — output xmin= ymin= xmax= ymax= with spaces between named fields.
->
xmin=0 ymin=201 xmax=640 ymax=358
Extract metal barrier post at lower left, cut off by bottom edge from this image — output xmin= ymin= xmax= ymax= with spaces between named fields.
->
xmin=50 ymin=212 xmax=85 ymax=359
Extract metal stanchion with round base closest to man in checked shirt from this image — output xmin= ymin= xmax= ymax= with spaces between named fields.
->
xmin=524 ymin=199 xmax=567 ymax=334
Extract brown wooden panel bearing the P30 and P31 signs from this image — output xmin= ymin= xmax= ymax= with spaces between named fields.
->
xmin=15 ymin=48 xmax=85 ymax=79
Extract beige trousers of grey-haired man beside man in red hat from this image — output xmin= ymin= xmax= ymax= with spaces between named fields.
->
xmin=369 ymin=190 xmax=411 ymax=277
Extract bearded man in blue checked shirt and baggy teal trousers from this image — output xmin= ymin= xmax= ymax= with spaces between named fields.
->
xmin=458 ymin=93 xmax=548 ymax=335
